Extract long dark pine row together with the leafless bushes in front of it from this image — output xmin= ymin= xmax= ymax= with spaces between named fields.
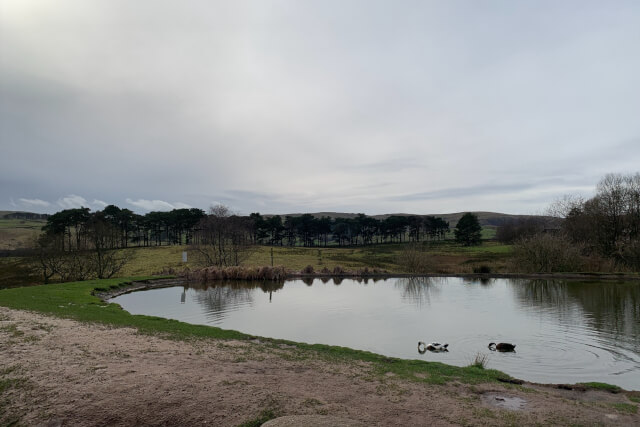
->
xmin=37 ymin=205 xmax=456 ymax=274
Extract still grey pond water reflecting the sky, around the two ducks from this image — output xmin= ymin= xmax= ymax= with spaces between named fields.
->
xmin=111 ymin=278 xmax=640 ymax=390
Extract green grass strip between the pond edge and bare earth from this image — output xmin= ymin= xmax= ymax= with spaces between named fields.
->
xmin=0 ymin=279 xmax=508 ymax=384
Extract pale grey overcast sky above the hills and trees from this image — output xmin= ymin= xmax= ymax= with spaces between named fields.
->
xmin=0 ymin=0 xmax=640 ymax=214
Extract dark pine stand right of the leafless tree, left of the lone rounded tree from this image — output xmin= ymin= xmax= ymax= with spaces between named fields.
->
xmin=249 ymin=213 xmax=449 ymax=247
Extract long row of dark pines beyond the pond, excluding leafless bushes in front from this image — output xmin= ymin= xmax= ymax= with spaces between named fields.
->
xmin=43 ymin=205 xmax=449 ymax=251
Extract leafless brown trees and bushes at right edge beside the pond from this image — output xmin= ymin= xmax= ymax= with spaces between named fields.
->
xmin=504 ymin=173 xmax=640 ymax=272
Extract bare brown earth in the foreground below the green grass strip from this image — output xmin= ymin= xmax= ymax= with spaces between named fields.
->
xmin=0 ymin=307 xmax=640 ymax=426
